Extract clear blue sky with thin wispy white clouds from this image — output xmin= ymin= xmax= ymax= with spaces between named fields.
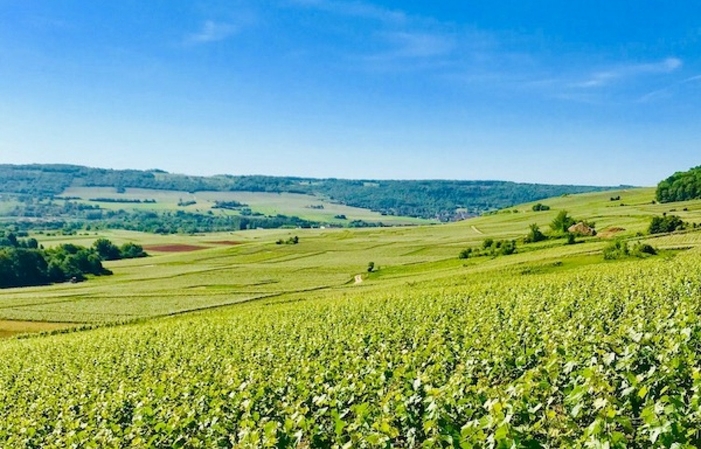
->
xmin=0 ymin=0 xmax=701 ymax=185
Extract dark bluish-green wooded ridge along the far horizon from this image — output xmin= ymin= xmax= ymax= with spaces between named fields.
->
xmin=0 ymin=164 xmax=609 ymax=221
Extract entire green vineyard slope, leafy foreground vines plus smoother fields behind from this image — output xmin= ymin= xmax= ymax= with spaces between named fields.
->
xmin=0 ymin=189 xmax=701 ymax=448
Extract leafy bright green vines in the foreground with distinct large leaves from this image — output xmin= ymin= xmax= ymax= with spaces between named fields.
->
xmin=0 ymin=250 xmax=701 ymax=448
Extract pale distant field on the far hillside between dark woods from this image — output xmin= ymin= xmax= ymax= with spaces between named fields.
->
xmin=62 ymin=187 xmax=431 ymax=225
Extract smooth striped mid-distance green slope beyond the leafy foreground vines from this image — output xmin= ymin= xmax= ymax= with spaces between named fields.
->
xmin=0 ymin=189 xmax=701 ymax=323
